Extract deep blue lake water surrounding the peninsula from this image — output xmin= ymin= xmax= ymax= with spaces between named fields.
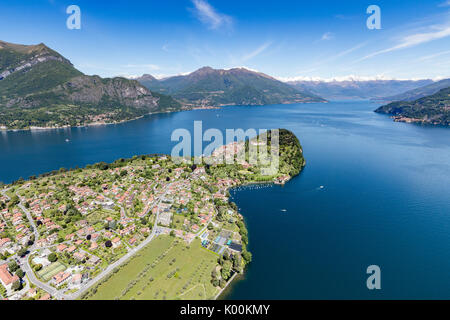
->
xmin=0 ymin=102 xmax=450 ymax=299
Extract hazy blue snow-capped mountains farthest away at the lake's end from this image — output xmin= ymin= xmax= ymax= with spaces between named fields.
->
xmin=287 ymin=80 xmax=433 ymax=100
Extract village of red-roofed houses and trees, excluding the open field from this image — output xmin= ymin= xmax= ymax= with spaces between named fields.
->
xmin=0 ymin=156 xmax=253 ymax=300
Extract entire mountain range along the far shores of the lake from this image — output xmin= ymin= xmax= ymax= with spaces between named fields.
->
xmin=0 ymin=41 xmax=450 ymax=129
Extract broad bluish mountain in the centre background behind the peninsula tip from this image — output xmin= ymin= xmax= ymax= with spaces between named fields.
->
xmin=137 ymin=67 xmax=325 ymax=107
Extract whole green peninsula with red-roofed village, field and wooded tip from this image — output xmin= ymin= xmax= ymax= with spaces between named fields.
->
xmin=0 ymin=129 xmax=305 ymax=300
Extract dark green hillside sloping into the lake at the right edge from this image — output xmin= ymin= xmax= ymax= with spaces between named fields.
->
xmin=375 ymin=87 xmax=450 ymax=126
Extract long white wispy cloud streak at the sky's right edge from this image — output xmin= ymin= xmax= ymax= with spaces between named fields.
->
xmin=355 ymin=26 xmax=450 ymax=62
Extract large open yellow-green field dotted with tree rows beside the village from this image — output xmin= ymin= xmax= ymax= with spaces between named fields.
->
xmin=87 ymin=236 xmax=218 ymax=300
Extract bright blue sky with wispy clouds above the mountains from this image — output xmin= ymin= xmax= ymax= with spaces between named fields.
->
xmin=0 ymin=0 xmax=450 ymax=79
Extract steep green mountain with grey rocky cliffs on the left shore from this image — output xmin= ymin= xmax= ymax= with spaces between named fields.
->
xmin=0 ymin=41 xmax=181 ymax=129
